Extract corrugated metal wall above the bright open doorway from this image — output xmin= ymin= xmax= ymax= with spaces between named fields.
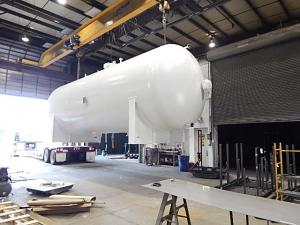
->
xmin=0 ymin=37 xmax=68 ymax=99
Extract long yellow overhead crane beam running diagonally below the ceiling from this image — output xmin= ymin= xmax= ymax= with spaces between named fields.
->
xmin=36 ymin=0 xmax=157 ymax=67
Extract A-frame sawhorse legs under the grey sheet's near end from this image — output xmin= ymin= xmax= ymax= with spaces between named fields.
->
xmin=155 ymin=193 xmax=191 ymax=225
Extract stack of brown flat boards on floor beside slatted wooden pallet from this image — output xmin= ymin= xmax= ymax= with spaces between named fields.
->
xmin=27 ymin=195 xmax=96 ymax=215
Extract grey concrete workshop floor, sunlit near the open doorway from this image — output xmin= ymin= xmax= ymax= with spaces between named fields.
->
xmin=0 ymin=157 xmax=282 ymax=225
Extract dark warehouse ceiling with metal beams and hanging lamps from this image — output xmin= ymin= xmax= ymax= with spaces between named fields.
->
xmin=0 ymin=0 xmax=300 ymax=77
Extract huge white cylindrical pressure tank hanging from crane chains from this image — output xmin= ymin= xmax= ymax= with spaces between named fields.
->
xmin=49 ymin=45 xmax=210 ymax=142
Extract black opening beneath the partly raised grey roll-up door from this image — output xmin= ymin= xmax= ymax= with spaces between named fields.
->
xmin=218 ymin=122 xmax=300 ymax=170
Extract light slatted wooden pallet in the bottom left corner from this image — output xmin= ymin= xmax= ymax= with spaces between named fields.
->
xmin=0 ymin=201 xmax=55 ymax=225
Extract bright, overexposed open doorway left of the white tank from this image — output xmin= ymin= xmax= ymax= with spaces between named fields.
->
xmin=0 ymin=95 xmax=50 ymax=160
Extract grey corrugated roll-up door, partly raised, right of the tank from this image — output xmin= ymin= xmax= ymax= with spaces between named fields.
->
xmin=211 ymin=40 xmax=300 ymax=125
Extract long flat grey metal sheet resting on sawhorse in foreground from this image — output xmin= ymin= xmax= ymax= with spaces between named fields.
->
xmin=143 ymin=179 xmax=300 ymax=225
